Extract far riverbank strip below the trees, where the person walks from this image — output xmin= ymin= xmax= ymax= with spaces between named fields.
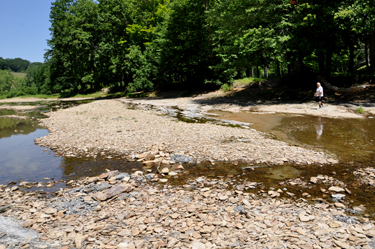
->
xmin=0 ymin=86 xmax=375 ymax=118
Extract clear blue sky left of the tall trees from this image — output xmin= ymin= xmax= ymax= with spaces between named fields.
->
xmin=0 ymin=0 xmax=54 ymax=62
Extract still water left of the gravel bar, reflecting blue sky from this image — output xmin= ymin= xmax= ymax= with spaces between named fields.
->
xmin=0 ymin=101 xmax=141 ymax=188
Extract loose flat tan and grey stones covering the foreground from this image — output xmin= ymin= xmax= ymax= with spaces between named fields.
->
xmin=0 ymin=171 xmax=375 ymax=249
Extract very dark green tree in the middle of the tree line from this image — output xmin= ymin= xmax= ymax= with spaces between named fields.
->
xmin=160 ymin=0 xmax=213 ymax=87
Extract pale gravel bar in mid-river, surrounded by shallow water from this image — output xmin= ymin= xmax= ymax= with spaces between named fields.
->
xmin=35 ymin=100 xmax=337 ymax=164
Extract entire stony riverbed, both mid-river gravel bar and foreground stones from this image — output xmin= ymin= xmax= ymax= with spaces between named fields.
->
xmin=0 ymin=96 xmax=375 ymax=249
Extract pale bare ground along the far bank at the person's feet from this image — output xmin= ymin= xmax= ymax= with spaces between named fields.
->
xmin=0 ymin=90 xmax=375 ymax=118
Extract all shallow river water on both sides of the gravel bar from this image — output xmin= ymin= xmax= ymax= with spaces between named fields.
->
xmin=0 ymin=102 xmax=375 ymax=213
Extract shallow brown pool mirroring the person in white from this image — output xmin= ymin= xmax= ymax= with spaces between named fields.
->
xmin=214 ymin=112 xmax=375 ymax=163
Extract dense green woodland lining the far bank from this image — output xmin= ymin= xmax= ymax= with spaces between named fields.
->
xmin=0 ymin=0 xmax=375 ymax=97
